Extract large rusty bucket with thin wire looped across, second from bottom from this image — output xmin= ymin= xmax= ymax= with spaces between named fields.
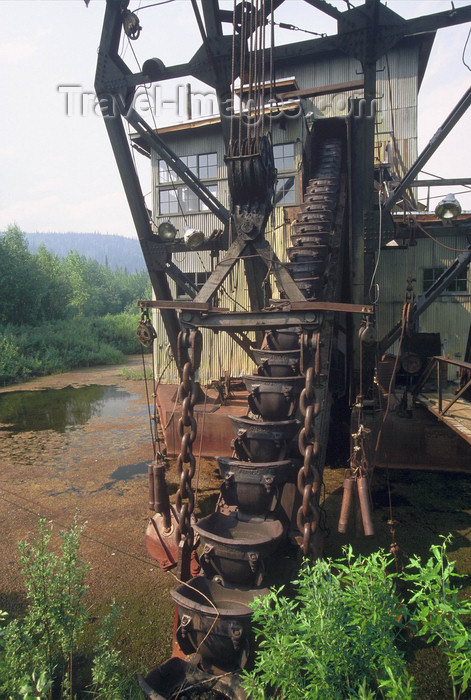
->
xmin=170 ymin=576 xmax=268 ymax=671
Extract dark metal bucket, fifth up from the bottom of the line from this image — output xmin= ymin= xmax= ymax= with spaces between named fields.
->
xmin=229 ymin=416 xmax=300 ymax=462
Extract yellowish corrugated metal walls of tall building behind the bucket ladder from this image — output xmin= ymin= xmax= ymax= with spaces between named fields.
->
xmin=152 ymin=48 xmax=424 ymax=383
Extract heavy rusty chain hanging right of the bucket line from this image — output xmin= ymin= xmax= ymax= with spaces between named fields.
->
xmin=297 ymin=333 xmax=323 ymax=557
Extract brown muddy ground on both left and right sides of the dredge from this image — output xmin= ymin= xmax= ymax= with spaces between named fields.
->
xmin=0 ymin=357 xmax=471 ymax=700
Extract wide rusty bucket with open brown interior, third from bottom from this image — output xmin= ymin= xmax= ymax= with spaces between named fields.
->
xmin=194 ymin=512 xmax=284 ymax=587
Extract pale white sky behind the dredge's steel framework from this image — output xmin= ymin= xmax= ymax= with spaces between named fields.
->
xmin=0 ymin=0 xmax=471 ymax=236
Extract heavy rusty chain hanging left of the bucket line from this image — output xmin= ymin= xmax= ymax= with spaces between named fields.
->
xmin=175 ymin=331 xmax=201 ymax=548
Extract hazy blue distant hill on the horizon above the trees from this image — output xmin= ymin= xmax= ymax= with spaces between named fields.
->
xmin=25 ymin=233 xmax=146 ymax=272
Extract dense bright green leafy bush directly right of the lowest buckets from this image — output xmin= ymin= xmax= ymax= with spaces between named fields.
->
xmin=244 ymin=548 xmax=412 ymax=700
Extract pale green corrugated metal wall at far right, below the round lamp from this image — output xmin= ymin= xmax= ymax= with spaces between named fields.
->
xmin=376 ymin=236 xmax=471 ymax=379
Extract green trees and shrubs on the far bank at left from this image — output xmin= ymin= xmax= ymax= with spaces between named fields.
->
xmin=0 ymin=226 xmax=151 ymax=384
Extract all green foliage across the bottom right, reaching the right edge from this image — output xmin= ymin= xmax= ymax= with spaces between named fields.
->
xmin=243 ymin=538 xmax=471 ymax=700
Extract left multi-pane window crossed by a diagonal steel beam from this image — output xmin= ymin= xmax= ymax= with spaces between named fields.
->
xmin=159 ymin=153 xmax=218 ymax=214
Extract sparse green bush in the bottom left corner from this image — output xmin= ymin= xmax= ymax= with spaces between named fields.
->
xmin=0 ymin=519 xmax=142 ymax=700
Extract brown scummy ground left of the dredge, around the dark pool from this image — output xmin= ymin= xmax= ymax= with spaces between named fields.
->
xmin=0 ymin=357 xmax=218 ymax=671
